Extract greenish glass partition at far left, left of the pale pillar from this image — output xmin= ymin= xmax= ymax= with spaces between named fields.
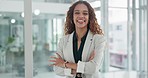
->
xmin=0 ymin=0 xmax=25 ymax=78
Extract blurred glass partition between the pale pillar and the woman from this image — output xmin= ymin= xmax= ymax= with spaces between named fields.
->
xmin=32 ymin=0 xmax=68 ymax=78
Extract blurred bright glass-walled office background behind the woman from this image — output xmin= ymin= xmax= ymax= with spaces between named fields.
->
xmin=0 ymin=0 xmax=148 ymax=78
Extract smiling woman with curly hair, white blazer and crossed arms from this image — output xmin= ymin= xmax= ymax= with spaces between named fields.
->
xmin=50 ymin=1 xmax=105 ymax=78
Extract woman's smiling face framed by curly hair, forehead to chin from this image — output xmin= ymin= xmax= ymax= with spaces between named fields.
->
xmin=73 ymin=4 xmax=89 ymax=28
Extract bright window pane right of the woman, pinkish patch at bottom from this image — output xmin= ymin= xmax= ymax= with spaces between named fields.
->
xmin=109 ymin=8 xmax=128 ymax=70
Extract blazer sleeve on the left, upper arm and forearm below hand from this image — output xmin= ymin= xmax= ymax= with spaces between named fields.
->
xmin=53 ymin=37 xmax=73 ymax=76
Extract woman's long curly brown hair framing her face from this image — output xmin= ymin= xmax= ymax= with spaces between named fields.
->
xmin=64 ymin=1 xmax=103 ymax=35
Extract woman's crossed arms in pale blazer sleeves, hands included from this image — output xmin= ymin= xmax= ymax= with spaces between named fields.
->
xmin=50 ymin=35 xmax=106 ymax=76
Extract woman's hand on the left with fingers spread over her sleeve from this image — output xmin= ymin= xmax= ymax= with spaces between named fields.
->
xmin=49 ymin=53 xmax=65 ymax=67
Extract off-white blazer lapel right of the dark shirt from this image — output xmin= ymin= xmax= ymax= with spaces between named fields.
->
xmin=82 ymin=30 xmax=93 ymax=61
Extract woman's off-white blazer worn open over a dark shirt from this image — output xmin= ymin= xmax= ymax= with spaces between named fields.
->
xmin=54 ymin=30 xmax=106 ymax=78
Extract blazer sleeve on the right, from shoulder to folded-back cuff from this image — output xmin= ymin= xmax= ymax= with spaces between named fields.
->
xmin=77 ymin=34 xmax=106 ymax=74
